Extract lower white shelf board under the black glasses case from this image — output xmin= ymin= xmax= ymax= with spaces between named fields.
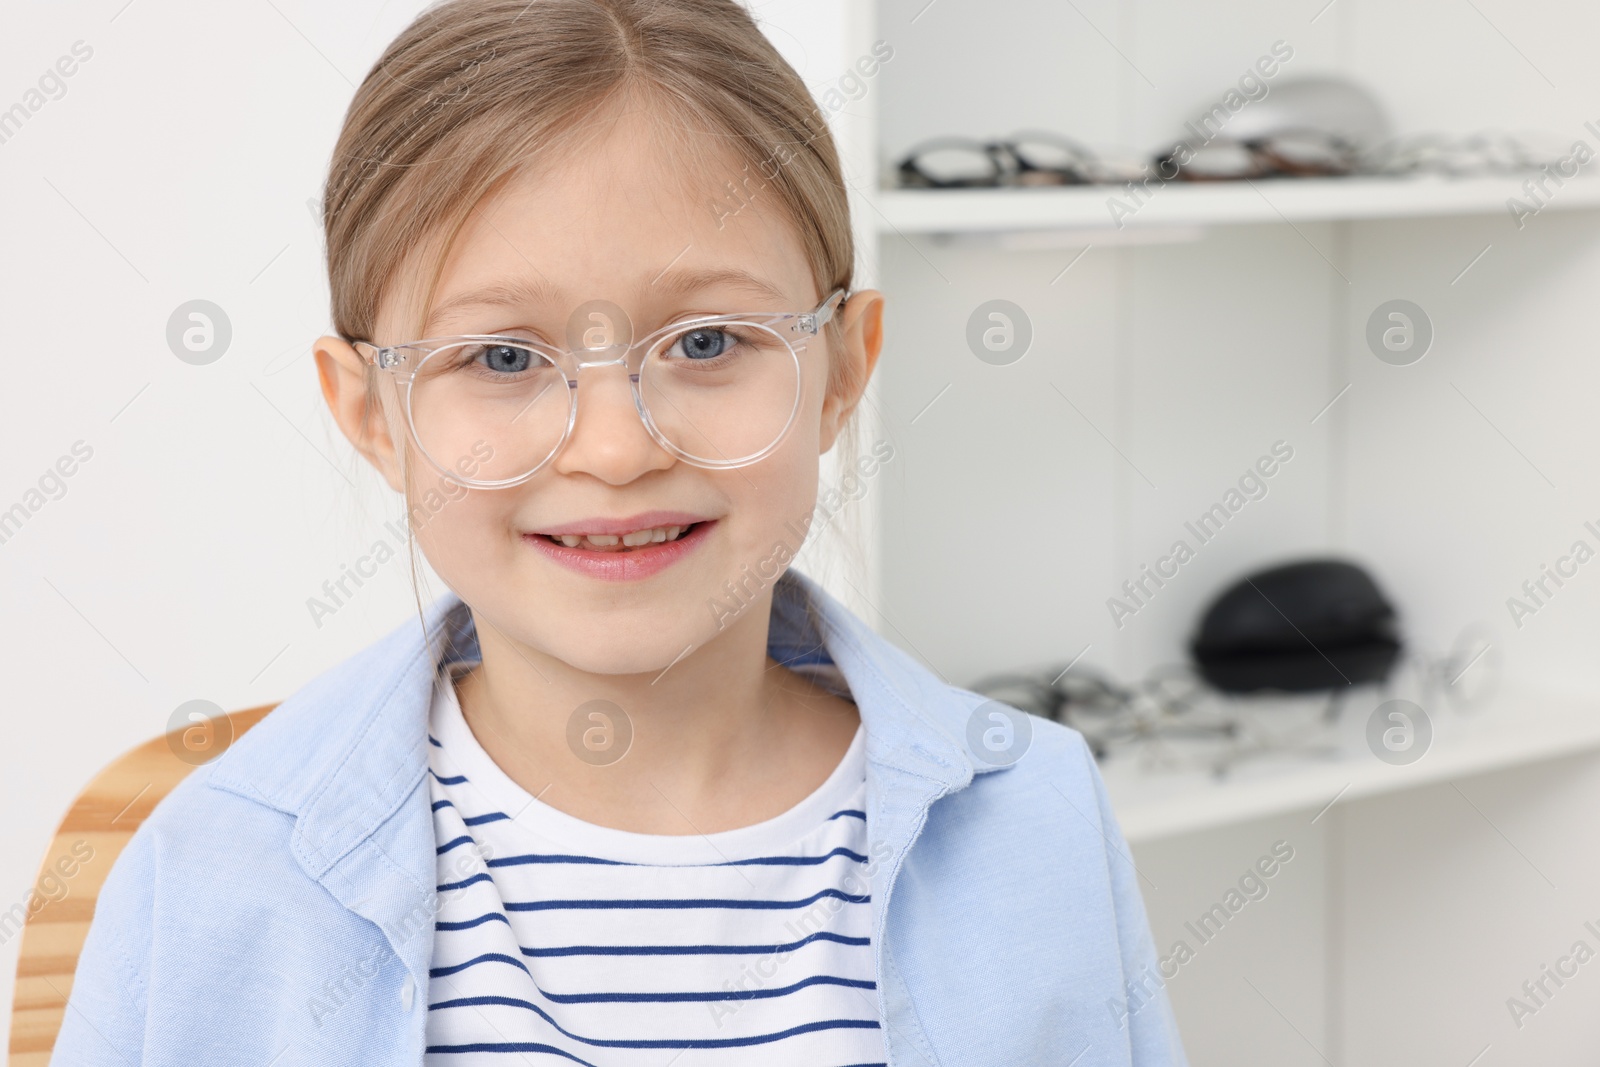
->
xmin=1101 ymin=689 xmax=1600 ymax=841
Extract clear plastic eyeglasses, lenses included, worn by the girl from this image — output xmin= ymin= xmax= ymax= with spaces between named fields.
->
xmin=350 ymin=290 xmax=845 ymax=490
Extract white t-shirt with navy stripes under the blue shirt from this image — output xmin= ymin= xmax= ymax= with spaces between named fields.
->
xmin=427 ymin=664 xmax=886 ymax=1067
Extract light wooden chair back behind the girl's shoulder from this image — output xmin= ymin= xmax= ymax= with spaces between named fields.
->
xmin=0 ymin=704 xmax=277 ymax=1067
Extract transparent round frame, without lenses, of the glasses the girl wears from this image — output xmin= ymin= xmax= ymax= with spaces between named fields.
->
xmin=346 ymin=286 xmax=846 ymax=490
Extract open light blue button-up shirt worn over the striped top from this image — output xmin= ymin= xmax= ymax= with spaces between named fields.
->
xmin=51 ymin=571 xmax=1186 ymax=1067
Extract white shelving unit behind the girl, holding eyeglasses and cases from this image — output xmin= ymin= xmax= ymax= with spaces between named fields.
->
xmin=808 ymin=0 xmax=1600 ymax=1067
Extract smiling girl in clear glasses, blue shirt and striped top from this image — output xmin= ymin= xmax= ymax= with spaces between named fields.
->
xmin=51 ymin=0 xmax=1184 ymax=1067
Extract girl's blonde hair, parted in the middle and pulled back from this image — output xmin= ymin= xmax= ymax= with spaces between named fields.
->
xmin=310 ymin=0 xmax=866 ymax=633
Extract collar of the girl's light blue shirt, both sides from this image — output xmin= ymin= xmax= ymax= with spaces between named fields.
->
xmin=210 ymin=569 xmax=995 ymax=878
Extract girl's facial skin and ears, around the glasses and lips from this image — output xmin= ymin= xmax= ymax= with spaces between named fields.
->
xmin=322 ymin=109 xmax=883 ymax=673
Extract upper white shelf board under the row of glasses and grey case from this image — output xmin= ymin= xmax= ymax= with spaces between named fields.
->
xmin=870 ymin=174 xmax=1600 ymax=234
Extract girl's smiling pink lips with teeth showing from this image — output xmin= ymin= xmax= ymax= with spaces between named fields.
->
xmin=523 ymin=512 xmax=717 ymax=581
